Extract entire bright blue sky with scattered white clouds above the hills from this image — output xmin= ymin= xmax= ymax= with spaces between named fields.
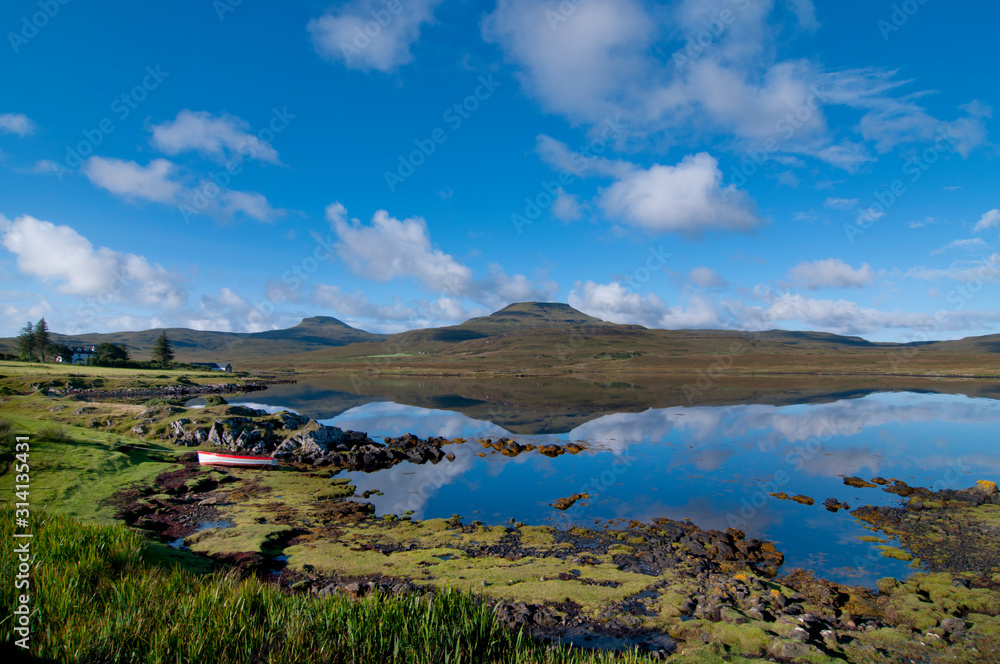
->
xmin=0 ymin=0 xmax=1000 ymax=340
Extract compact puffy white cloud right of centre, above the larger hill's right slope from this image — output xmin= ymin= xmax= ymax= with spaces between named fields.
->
xmin=599 ymin=152 xmax=765 ymax=236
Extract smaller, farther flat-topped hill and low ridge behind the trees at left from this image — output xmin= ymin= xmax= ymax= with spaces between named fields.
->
xmin=0 ymin=316 xmax=385 ymax=362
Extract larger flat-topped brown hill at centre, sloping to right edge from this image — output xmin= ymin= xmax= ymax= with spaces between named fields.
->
xmin=259 ymin=302 xmax=1000 ymax=376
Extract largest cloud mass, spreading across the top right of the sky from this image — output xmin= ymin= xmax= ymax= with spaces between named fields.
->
xmin=483 ymin=0 xmax=991 ymax=172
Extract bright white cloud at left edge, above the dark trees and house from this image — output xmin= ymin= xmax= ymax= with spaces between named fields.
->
xmin=0 ymin=215 xmax=187 ymax=308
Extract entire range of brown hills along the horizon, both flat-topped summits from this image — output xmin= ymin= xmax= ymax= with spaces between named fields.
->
xmin=0 ymin=302 xmax=1000 ymax=374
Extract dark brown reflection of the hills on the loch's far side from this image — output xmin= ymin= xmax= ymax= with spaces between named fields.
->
xmin=244 ymin=376 xmax=1000 ymax=435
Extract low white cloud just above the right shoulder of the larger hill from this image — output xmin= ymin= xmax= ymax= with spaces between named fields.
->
xmin=568 ymin=281 xmax=720 ymax=329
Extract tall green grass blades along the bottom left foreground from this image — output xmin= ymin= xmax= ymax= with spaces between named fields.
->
xmin=0 ymin=505 xmax=672 ymax=664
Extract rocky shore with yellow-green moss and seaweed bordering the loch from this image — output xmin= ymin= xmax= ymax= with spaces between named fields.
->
xmin=23 ymin=390 xmax=1000 ymax=664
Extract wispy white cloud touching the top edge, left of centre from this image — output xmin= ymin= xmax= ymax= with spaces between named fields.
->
xmin=307 ymin=0 xmax=441 ymax=72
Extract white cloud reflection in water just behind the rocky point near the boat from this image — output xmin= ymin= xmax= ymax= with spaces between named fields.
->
xmin=321 ymin=401 xmax=508 ymax=438
